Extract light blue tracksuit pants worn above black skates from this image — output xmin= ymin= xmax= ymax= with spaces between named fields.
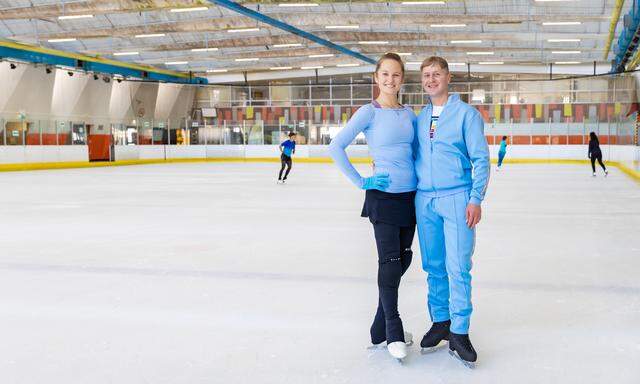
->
xmin=416 ymin=191 xmax=475 ymax=334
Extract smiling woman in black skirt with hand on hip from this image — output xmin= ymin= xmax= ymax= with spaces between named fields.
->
xmin=329 ymin=53 xmax=417 ymax=361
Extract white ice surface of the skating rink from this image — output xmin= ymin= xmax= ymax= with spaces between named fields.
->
xmin=0 ymin=163 xmax=640 ymax=384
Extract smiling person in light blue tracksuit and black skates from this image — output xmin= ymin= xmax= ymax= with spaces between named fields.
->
xmin=416 ymin=57 xmax=490 ymax=367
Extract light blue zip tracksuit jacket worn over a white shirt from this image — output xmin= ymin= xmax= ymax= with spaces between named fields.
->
xmin=416 ymin=94 xmax=490 ymax=205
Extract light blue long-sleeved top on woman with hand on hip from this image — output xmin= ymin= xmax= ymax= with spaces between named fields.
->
xmin=329 ymin=104 xmax=417 ymax=193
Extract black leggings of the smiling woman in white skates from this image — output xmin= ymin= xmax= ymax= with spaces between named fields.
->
xmin=371 ymin=222 xmax=416 ymax=344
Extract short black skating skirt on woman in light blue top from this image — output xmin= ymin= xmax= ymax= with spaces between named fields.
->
xmin=360 ymin=189 xmax=416 ymax=227
